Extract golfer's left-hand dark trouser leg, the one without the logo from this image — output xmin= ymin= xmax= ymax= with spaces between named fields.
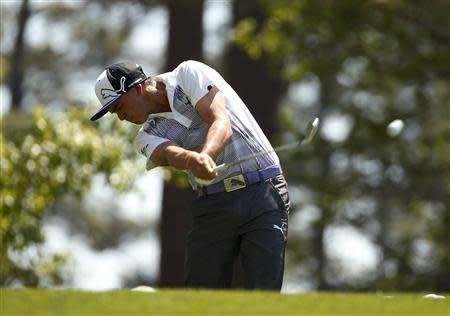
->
xmin=185 ymin=194 xmax=238 ymax=288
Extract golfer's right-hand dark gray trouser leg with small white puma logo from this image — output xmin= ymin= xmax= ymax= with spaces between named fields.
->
xmin=240 ymin=176 xmax=289 ymax=291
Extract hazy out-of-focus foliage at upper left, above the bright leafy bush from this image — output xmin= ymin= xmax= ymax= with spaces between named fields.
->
xmin=0 ymin=0 xmax=161 ymax=109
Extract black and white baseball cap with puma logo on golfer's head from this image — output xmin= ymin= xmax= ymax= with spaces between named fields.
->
xmin=91 ymin=62 xmax=147 ymax=121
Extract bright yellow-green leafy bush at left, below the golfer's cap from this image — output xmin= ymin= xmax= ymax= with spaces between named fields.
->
xmin=0 ymin=108 xmax=136 ymax=286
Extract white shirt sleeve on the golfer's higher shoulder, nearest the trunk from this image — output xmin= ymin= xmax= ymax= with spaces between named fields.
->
xmin=177 ymin=60 xmax=217 ymax=107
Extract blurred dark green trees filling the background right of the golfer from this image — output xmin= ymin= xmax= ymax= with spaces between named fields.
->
xmin=237 ymin=0 xmax=450 ymax=291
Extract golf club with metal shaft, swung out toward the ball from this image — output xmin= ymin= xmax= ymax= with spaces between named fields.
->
xmin=195 ymin=117 xmax=319 ymax=185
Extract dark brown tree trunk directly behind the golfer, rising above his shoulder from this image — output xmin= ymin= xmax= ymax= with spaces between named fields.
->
xmin=158 ymin=0 xmax=203 ymax=287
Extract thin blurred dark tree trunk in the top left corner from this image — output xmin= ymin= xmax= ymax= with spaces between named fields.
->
xmin=8 ymin=0 xmax=30 ymax=110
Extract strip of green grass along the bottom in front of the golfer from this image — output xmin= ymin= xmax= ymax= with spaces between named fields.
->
xmin=0 ymin=289 xmax=450 ymax=316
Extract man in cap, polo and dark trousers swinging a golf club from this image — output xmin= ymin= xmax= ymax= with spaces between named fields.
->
xmin=91 ymin=60 xmax=289 ymax=291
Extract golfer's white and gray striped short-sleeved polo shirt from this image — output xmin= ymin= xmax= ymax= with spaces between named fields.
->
xmin=135 ymin=60 xmax=279 ymax=189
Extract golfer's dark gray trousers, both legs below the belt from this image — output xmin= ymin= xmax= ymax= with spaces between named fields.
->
xmin=185 ymin=175 xmax=289 ymax=291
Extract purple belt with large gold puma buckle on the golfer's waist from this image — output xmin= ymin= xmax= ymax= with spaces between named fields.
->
xmin=197 ymin=166 xmax=282 ymax=196
